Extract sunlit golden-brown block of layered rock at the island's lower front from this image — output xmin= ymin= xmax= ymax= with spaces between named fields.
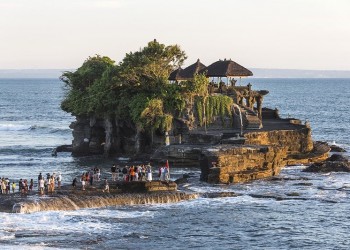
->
xmin=201 ymin=145 xmax=287 ymax=183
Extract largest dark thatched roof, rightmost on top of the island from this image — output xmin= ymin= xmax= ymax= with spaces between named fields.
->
xmin=199 ymin=60 xmax=253 ymax=77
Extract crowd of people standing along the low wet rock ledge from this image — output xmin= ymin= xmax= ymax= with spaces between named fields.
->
xmin=0 ymin=163 xmax=170 ymax=195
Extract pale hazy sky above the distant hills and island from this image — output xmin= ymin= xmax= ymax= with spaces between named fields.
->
xmin=0 ymin=0 xmax=350 ymax=70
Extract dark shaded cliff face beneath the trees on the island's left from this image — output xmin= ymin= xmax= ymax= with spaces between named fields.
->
xmin=70 ymin=116 xmax=178 ymax=156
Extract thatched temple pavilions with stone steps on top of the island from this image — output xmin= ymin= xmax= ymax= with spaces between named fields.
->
xmin=168 ymin=59 xmax=269 ymax=133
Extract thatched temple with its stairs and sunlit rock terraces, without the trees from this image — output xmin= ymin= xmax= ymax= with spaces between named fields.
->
xmin=152 ymin=59 xmax=329 ymax=183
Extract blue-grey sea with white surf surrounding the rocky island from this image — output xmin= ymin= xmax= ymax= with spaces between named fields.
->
xmin=0 ymin=78 xmax=350 ymax=249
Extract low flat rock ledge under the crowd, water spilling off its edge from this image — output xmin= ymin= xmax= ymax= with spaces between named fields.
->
xmin=0 ymin=181 xmax=198 ymax=213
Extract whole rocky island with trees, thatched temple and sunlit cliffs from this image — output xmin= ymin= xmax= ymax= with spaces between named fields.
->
xmin=61 ymin=40 xmax=330 ymax=183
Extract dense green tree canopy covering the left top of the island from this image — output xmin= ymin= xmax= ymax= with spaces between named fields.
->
xmin=60 ymin=40 xmax=235 ymax=136
